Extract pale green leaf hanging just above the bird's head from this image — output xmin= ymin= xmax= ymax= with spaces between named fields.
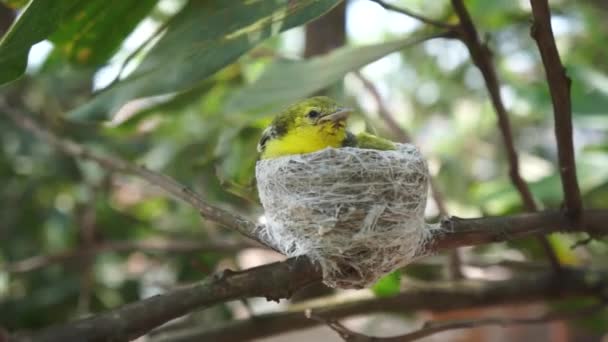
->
xmin=226 ymin=38 xmax=430 ymax=112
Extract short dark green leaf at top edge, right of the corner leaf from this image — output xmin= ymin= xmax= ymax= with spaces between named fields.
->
xmin=50 ymin=0 xmax=157 ymax=65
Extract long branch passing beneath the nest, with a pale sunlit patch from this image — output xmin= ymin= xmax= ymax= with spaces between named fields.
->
xmin=151 ymin=269 xmax=608 ymax=342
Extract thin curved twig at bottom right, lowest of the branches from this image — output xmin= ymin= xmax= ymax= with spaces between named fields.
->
xmin=307 ymin=303 xmax=605 ymax=342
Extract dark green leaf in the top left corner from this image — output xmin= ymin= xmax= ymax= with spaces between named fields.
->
xmin=0 ymin=0 xmax=79 ymax=84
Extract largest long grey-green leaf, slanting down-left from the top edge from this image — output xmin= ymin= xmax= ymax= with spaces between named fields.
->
xmin=68 ymin=0 xmax=340 ymax=120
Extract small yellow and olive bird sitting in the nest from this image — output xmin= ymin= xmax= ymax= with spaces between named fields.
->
xmin=257 ymin=96 xmax=396 ymax=159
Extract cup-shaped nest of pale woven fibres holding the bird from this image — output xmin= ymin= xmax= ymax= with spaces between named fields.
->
xmin=256 ymin=144 xmax=430 ymax=288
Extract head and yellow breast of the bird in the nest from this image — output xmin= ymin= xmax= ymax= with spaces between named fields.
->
xmin=258 ymin=96 xmax=352 ymax=153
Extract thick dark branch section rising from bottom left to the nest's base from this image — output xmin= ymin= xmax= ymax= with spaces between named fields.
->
xmin=14 ymin=258 xmax=321 ymax=342
